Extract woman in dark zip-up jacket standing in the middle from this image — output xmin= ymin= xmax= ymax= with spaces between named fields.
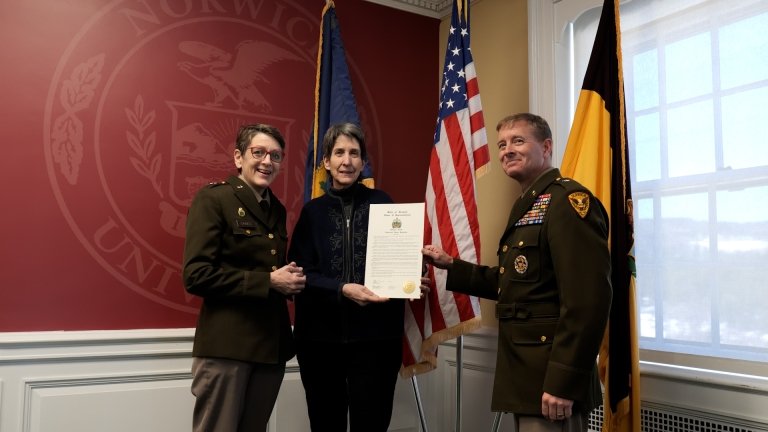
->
xmin=288 ymin=123 xmax=405 ymax=432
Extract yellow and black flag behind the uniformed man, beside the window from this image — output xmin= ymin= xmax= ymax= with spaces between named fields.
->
xmin=561 ymin=0 xmax=640 ymax=432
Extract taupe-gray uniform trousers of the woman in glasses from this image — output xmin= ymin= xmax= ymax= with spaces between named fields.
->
xmin=192 ymin=357 xmax=285 ymax=432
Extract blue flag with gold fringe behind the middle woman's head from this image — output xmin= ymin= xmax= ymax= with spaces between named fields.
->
xmin=304 ymin=1 xmax=373 ymax=202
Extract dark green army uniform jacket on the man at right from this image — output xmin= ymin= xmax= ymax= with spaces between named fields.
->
xmin=447 ymin=169 xmax=612 ymax=415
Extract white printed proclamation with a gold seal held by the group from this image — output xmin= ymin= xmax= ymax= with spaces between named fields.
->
xmin=365 ymin=203 xmax=424 ymax=299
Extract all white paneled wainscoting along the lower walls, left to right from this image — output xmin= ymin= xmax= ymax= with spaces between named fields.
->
xmin=0 ymin=329 xmax=768 ymax=432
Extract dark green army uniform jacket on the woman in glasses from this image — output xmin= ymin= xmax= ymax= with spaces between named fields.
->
xmin=183 ymin=176 xmax=294 ymax=364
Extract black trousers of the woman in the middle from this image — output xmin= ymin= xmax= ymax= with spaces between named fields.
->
xmin=296 ymin=338 xmax=403 ymax=432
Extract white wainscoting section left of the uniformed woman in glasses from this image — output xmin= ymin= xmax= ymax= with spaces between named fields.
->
xmin=0 ymin=329 xmax=198 ymax=432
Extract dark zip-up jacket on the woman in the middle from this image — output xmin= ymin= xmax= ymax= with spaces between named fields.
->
xmin=288 ymin=183 xmax=405 ymax=343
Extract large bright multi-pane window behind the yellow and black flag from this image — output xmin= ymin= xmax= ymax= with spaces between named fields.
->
xmin=556 ymin=0 xmax=768 ymax=375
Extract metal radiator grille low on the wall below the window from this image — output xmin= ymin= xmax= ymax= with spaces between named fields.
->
xmin=589 ymin=402 xmax=768 ymax=432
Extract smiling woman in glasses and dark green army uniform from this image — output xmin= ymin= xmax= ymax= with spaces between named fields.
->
xmin=183 ymin=124 xmax=306 ymax=432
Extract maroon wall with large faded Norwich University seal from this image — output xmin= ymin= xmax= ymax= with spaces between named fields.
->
xmin=0 ymin=0 xmax=440 ymax=331
